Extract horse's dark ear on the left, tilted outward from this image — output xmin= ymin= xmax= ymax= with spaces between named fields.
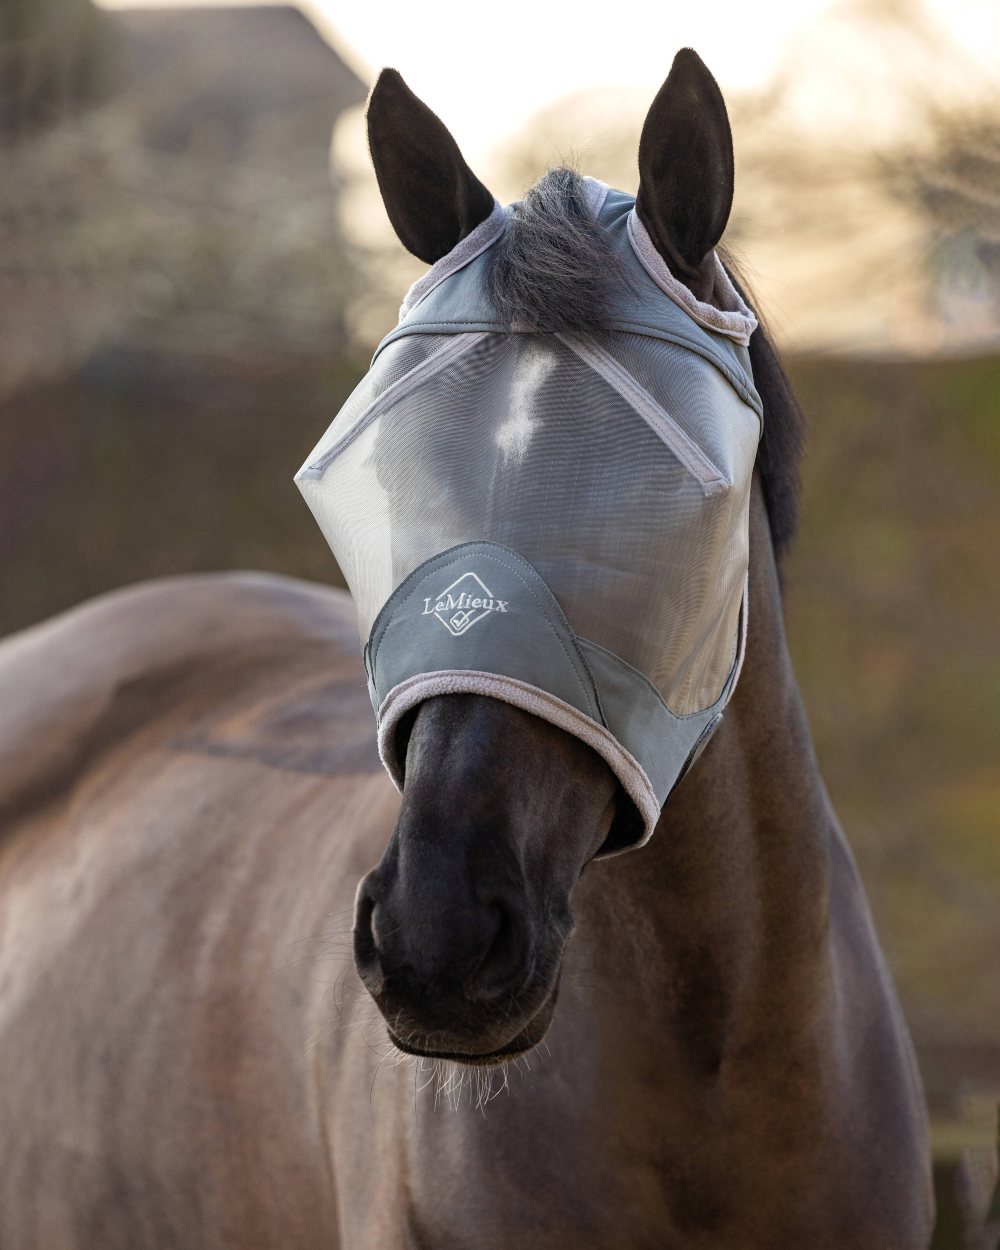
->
xmin=368 ymin=70 xmax=494 ymax=265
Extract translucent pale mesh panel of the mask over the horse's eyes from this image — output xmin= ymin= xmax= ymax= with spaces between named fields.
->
xmin=301 ymin=333 xmax=759 ymax=714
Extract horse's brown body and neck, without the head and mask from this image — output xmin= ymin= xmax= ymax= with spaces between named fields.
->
xmin=0 ymin=498 xmax=929 ymax=1250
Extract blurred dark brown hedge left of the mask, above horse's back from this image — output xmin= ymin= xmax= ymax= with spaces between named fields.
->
xmin=0 ymin=348 xmax=365 ymax=631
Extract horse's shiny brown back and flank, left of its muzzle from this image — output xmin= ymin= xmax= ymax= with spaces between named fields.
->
xmin=0 ymin=575 xmax=396 ymax=1250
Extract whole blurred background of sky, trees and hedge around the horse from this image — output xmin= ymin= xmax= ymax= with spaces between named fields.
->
xmin=0 ymin=0 xmax=1000 ymax=1250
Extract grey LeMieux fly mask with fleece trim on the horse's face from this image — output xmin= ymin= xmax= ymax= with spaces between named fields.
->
xmin=295 ymin=179 xmax=761 ymax=855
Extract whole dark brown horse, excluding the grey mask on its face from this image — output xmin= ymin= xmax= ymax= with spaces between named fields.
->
xmin=0 ymin=50 xmax=933 ymax=1250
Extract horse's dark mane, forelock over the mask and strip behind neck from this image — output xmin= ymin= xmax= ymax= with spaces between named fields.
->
xmin=488 ymin=168 xmax=804 ymax=558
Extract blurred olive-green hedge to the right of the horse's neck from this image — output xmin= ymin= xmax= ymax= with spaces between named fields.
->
xmin=788 ymin=356 xmax=1000 ymax=1065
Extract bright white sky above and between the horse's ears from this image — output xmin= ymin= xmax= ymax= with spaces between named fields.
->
xmin=103 ymin=0 xmax=1000 ymax=165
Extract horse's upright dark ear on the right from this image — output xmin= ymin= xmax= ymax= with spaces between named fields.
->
xmin=635 ymin=48 xmax=733 ymax=286
